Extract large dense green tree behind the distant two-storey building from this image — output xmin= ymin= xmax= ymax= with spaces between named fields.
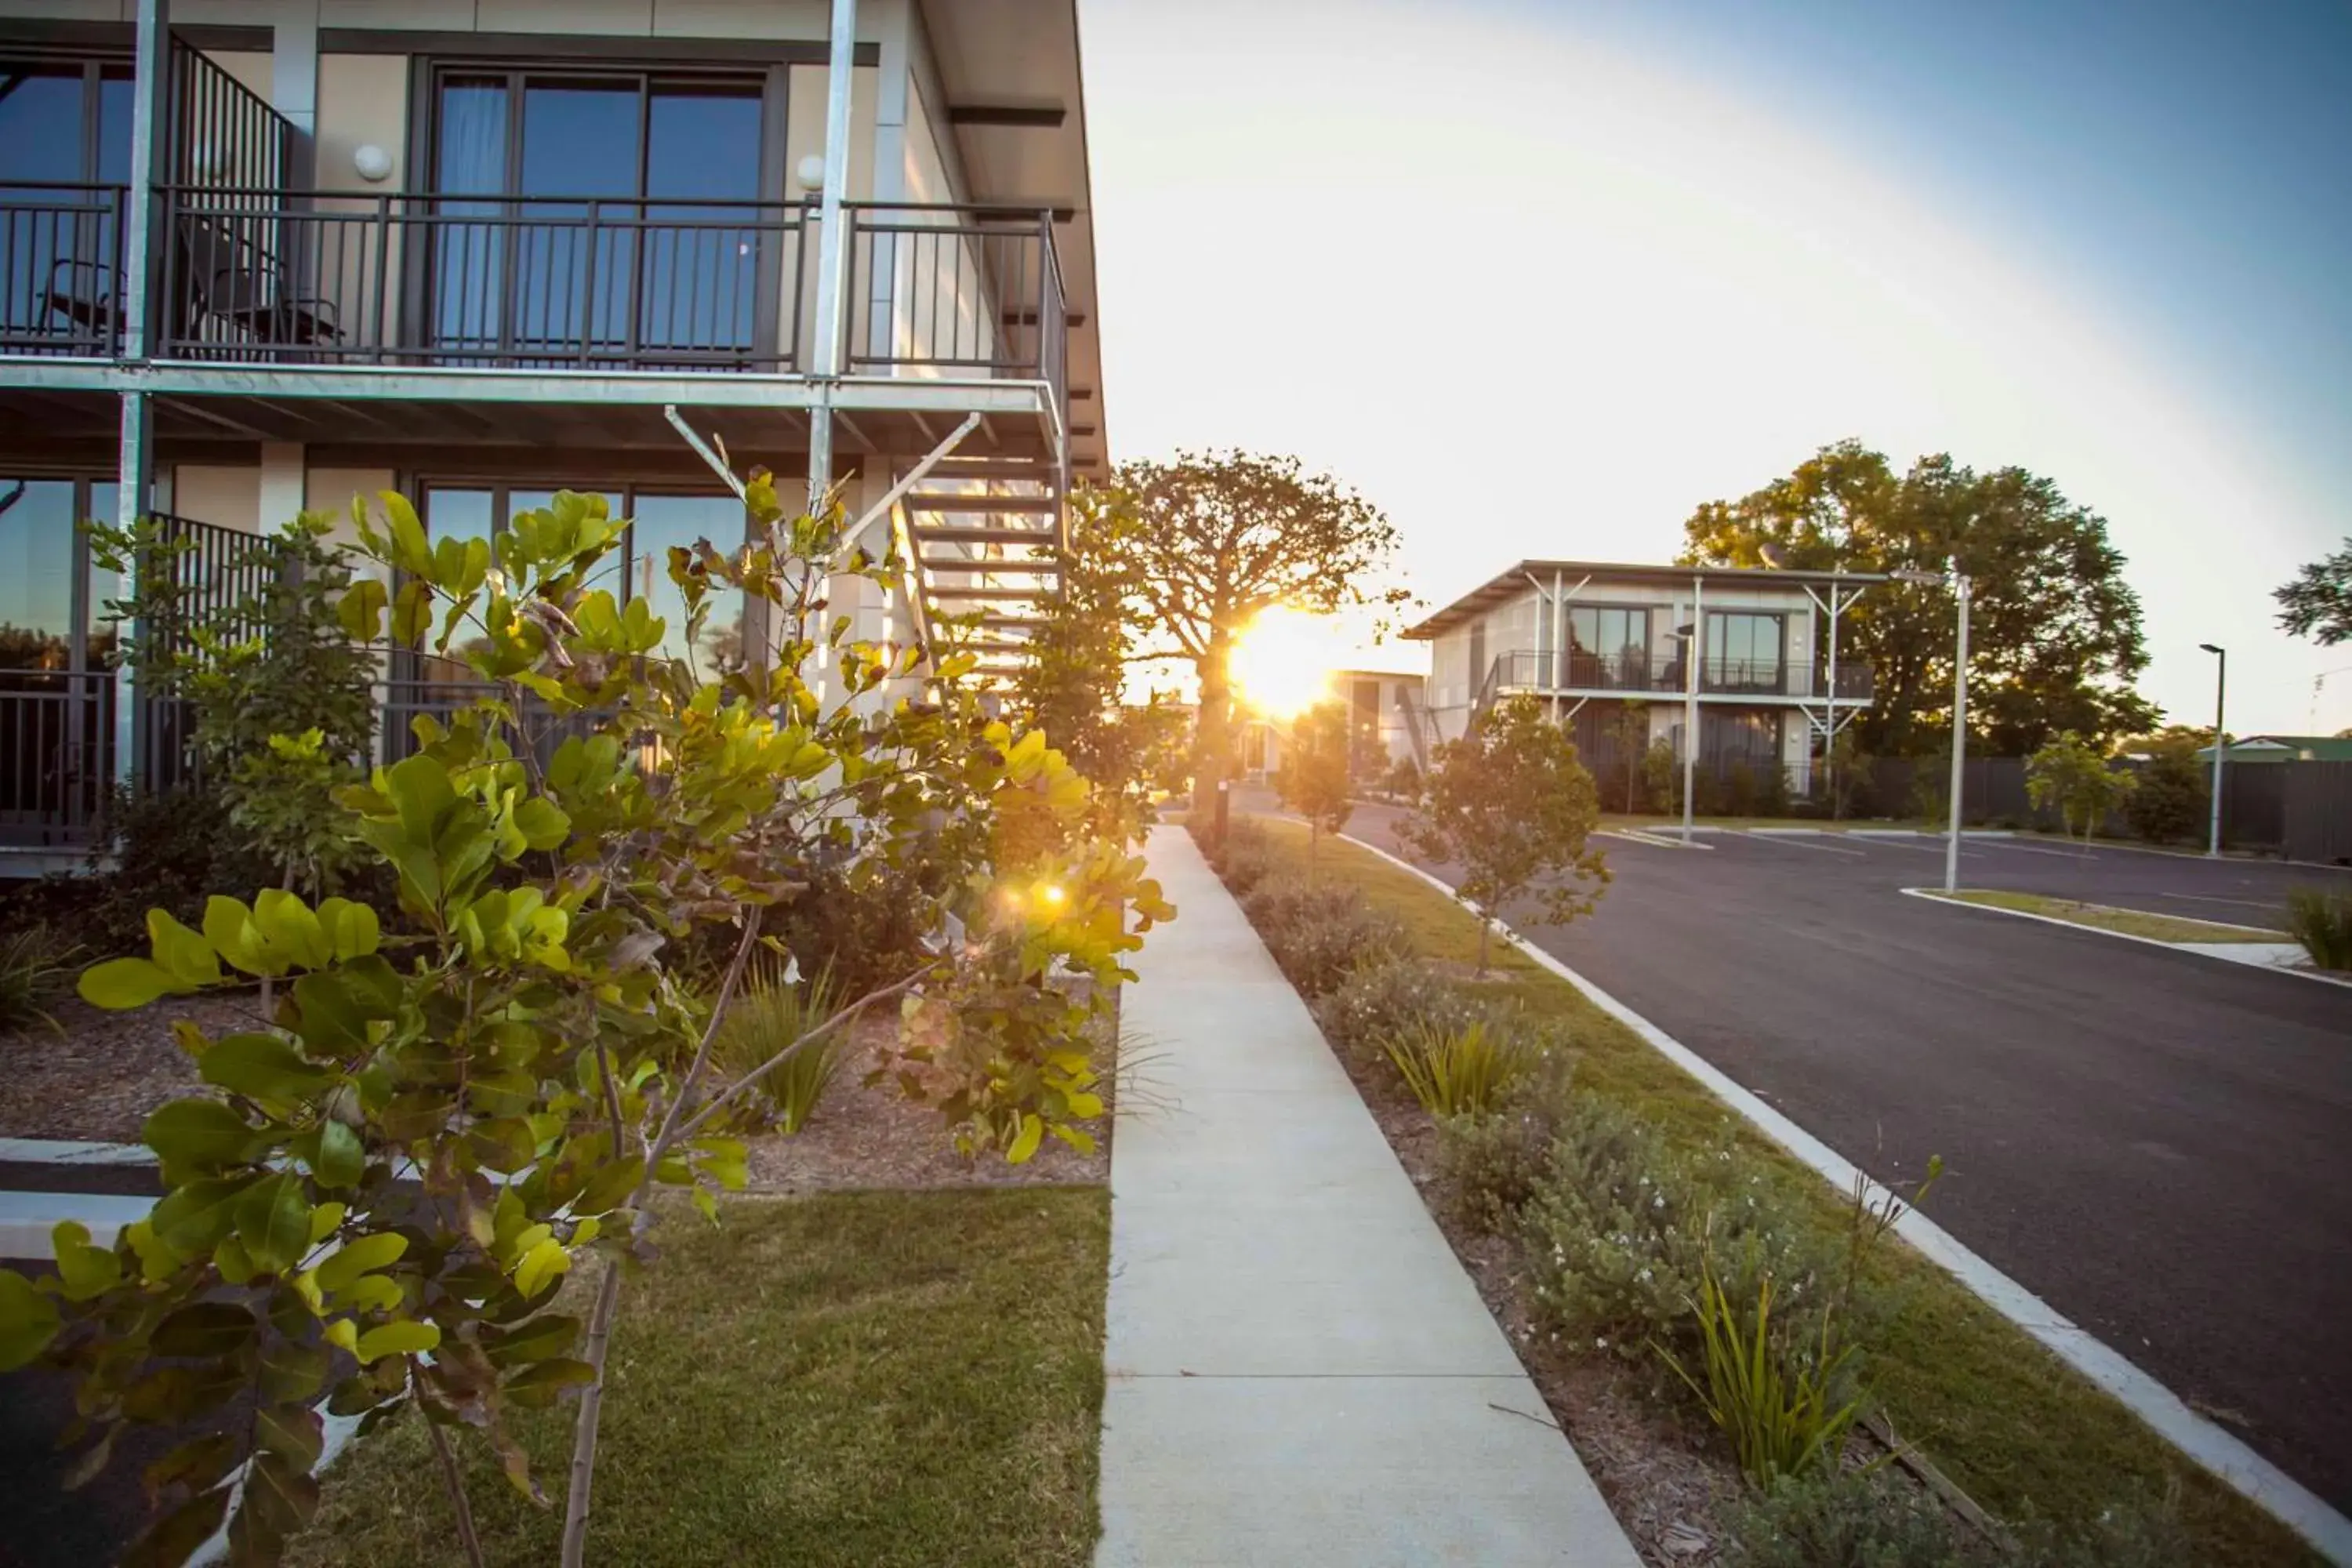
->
xmin=1684 ymin=440 xmax=2159 ymax=757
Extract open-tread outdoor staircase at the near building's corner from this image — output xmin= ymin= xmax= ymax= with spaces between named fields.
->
xmin=901 ymin=459 xmax=1068 ymax=684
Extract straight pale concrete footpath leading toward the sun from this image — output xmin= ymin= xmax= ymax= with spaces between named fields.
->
xmin=1094 ymin=827 xmax=1639 ymax=1568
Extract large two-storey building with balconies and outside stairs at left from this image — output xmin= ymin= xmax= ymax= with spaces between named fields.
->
xmin=0 ymin=0 xmax=1108 ymax=858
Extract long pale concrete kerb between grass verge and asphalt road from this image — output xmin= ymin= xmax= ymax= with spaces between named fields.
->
xmin=1338 ymin=834 xmax=2352 ymax=1568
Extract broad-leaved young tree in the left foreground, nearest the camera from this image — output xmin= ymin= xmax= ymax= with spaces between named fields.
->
xmin=0 ymin=475 xmax=1169 ymax=1568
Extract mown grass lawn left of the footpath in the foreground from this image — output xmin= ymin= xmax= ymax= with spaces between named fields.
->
xmin=289 ymin=1187 xmax=1110 ymax=1568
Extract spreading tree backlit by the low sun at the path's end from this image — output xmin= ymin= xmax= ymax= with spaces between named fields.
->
xmin=1110 ymin=452 xmax=1409 ymax=794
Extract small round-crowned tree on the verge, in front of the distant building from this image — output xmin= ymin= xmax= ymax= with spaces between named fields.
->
xmin=1397 ymin=696 xmax=1609 ymax=973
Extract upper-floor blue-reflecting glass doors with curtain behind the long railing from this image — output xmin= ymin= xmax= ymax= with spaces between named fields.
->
xmin=428 ymin=68 xmax=781 ymax=365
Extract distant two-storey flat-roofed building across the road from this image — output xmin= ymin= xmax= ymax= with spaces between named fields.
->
xmin=1404 ymin=560 xmax=1882 ymax=801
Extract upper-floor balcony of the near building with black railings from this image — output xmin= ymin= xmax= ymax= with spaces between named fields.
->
xmin=0 ymin=38 xmax=1070 ymax=459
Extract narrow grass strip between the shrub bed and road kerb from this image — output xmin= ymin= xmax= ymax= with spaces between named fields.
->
xmin=1261 ymin=818 xmax=2321 ymax=1568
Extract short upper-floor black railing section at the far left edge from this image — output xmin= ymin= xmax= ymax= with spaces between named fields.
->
xmin=0 ymin=181 xmax=129 ymax=360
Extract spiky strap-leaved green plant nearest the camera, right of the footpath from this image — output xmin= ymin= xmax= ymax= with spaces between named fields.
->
xmin=1661 ymin=1262 xmax=1863 ymax=1486
